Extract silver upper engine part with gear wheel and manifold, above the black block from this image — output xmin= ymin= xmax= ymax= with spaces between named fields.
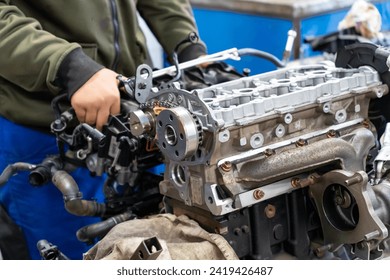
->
xmin=156 ymin=66 xmax=386 ymax=207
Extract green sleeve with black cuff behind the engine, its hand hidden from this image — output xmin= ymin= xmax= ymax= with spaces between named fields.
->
xmin=137 ymin=0 xmax=206 ymax=61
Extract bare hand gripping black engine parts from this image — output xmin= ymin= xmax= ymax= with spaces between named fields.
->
xmin=70 ymin=68 xmax=120 ymax=130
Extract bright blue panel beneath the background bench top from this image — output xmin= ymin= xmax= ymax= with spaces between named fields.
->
xmin=194 ymin=1 xmax=390 ymax=74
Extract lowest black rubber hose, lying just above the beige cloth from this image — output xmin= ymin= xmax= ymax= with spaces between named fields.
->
xmin=76 ymin=211 xmax=135 ymax=243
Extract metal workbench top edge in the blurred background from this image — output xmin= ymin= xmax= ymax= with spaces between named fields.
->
xmin=190 ymin=0 xmax=383 ymax=19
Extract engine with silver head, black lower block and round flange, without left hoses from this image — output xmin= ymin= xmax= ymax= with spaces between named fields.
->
xmin=129 ymin=63 xmax=389 ymax=259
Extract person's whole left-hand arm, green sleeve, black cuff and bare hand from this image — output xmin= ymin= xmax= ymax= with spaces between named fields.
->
xmin=0 ymin=0 xmax=119 ymax=130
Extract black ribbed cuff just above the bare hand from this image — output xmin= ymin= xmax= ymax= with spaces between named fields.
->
xmin=57 ymin=48 xmax=104 ymax=99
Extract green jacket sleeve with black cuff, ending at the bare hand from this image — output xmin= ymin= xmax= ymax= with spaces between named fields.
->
xmin=0 ymin=0 xmax=101 ymax=93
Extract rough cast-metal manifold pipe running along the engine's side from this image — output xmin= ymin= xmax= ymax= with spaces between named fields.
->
xmin=238 ymin=129 xmax=375 ymax=182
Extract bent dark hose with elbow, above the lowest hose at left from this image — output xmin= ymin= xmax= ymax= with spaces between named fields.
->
xmin=52 ymin=170 xmax=106 ymax=217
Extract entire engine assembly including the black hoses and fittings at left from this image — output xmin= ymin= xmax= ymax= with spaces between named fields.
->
xmin=1 ymin=43 xmax=390 ymax=259
